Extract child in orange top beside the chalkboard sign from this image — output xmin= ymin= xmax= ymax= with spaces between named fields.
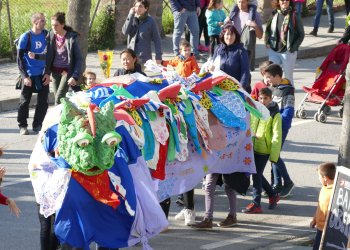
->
xmin=310 ymin=162 xmax=336 ymax=250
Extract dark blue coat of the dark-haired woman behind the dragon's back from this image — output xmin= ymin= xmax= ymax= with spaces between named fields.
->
xmin=213 ymin=43 xmax=250 ymax=90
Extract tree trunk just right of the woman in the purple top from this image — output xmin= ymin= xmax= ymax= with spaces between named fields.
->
xmin=66 ymin=0 xmax=91 ymax=71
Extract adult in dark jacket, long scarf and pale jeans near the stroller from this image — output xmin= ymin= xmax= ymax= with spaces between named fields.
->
xmin=265 ymin=0 xmax=305 ymax=84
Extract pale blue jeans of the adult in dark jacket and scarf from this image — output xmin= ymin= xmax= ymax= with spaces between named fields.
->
xmin=269 ymin=49 xmax=298 ymax=85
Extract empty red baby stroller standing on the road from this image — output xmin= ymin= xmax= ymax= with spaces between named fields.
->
xmin=295 ymin=44 xmax=350 ymax=123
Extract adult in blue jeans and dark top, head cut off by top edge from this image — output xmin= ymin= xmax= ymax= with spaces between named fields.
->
xmin=170 ymin=0 xmax=201 ymax=59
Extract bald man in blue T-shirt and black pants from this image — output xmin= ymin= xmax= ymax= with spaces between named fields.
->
xmin=17 ymin=13 xmax=49 ymax=135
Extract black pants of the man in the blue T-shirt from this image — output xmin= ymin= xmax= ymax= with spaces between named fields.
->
xmin=17 ymin=75 xmax=49 ymax=128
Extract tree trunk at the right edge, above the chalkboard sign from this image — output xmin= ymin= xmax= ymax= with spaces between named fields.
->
xmin=338 ymin=61 xmax=350 ymax=168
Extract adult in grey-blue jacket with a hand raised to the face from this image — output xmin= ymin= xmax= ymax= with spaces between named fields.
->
xmin=122 ymin=0 xmax=162 ymax=65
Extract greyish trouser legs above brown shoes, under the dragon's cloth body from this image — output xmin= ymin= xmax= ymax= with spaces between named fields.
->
xmin=205 ymin=174 xmax=237 ymax=220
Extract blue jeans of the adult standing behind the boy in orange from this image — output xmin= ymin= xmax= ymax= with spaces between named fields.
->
xmin=173 ymin=10 xmax=199 ymax=56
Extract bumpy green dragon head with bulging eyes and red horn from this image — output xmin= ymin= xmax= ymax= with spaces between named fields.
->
xmin=58 ymin=99 xmax=121 ymax=176
